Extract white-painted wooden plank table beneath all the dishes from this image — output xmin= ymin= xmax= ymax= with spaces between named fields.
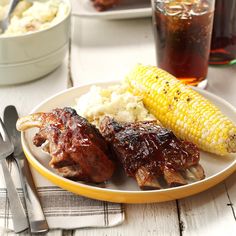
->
xmin=0 ymin=12 xmax=236 ymax=236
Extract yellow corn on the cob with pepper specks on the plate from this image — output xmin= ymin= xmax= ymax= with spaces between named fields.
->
xmin=126 ymin=65 xmax=236 ymax=155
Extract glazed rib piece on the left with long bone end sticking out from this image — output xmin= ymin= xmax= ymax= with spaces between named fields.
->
xmin=17 ymin=107 xmax=114 ymax=183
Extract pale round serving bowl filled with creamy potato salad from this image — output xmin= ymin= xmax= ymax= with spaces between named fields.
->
xmin=0 ymin=0 xmax=71 ymax=85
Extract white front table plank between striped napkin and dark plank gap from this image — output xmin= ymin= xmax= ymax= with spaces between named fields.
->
xmin=74 ymin=201 xmax=179 ymax=236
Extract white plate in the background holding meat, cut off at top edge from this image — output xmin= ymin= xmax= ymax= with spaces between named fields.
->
xmin=72 ymin=0 xmax=152 ymax=19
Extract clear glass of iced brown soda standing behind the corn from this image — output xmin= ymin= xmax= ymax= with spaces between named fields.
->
xmin=152 ymin=0 xmax=215 ymax=88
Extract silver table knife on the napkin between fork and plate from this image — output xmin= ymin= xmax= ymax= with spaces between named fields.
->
xmin=3 ymin=106 xmax=49 ymax=233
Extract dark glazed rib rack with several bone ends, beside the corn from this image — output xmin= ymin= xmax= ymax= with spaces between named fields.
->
xmin=100 ymin=117 xmax=205 ymax=190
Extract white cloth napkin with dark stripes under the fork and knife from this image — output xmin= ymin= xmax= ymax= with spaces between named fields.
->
xmin=0 ymin=159 xmax=124 ymax=232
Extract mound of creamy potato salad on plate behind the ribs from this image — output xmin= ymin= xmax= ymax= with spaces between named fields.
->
xmin=75 ymin=83 xmax=155 ymax=126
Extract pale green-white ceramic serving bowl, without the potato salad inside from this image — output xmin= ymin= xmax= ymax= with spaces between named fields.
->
xmin=0 ymin=0 xmax=71 ymax=85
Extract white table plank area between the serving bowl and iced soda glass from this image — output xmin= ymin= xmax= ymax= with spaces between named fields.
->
xmin=71 ymin=18 xmax=155 ymax=86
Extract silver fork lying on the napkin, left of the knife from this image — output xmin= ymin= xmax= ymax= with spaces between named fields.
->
xmin=0 ymin=118 xmax=29 ymax=233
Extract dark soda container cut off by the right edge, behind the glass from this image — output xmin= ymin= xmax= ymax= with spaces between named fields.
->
xmin=209 ymin=0 xmax=236 ymax=65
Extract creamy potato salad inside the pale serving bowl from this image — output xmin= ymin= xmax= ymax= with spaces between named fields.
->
xmin=0 ymin=0 xmax=69 ymax=35
